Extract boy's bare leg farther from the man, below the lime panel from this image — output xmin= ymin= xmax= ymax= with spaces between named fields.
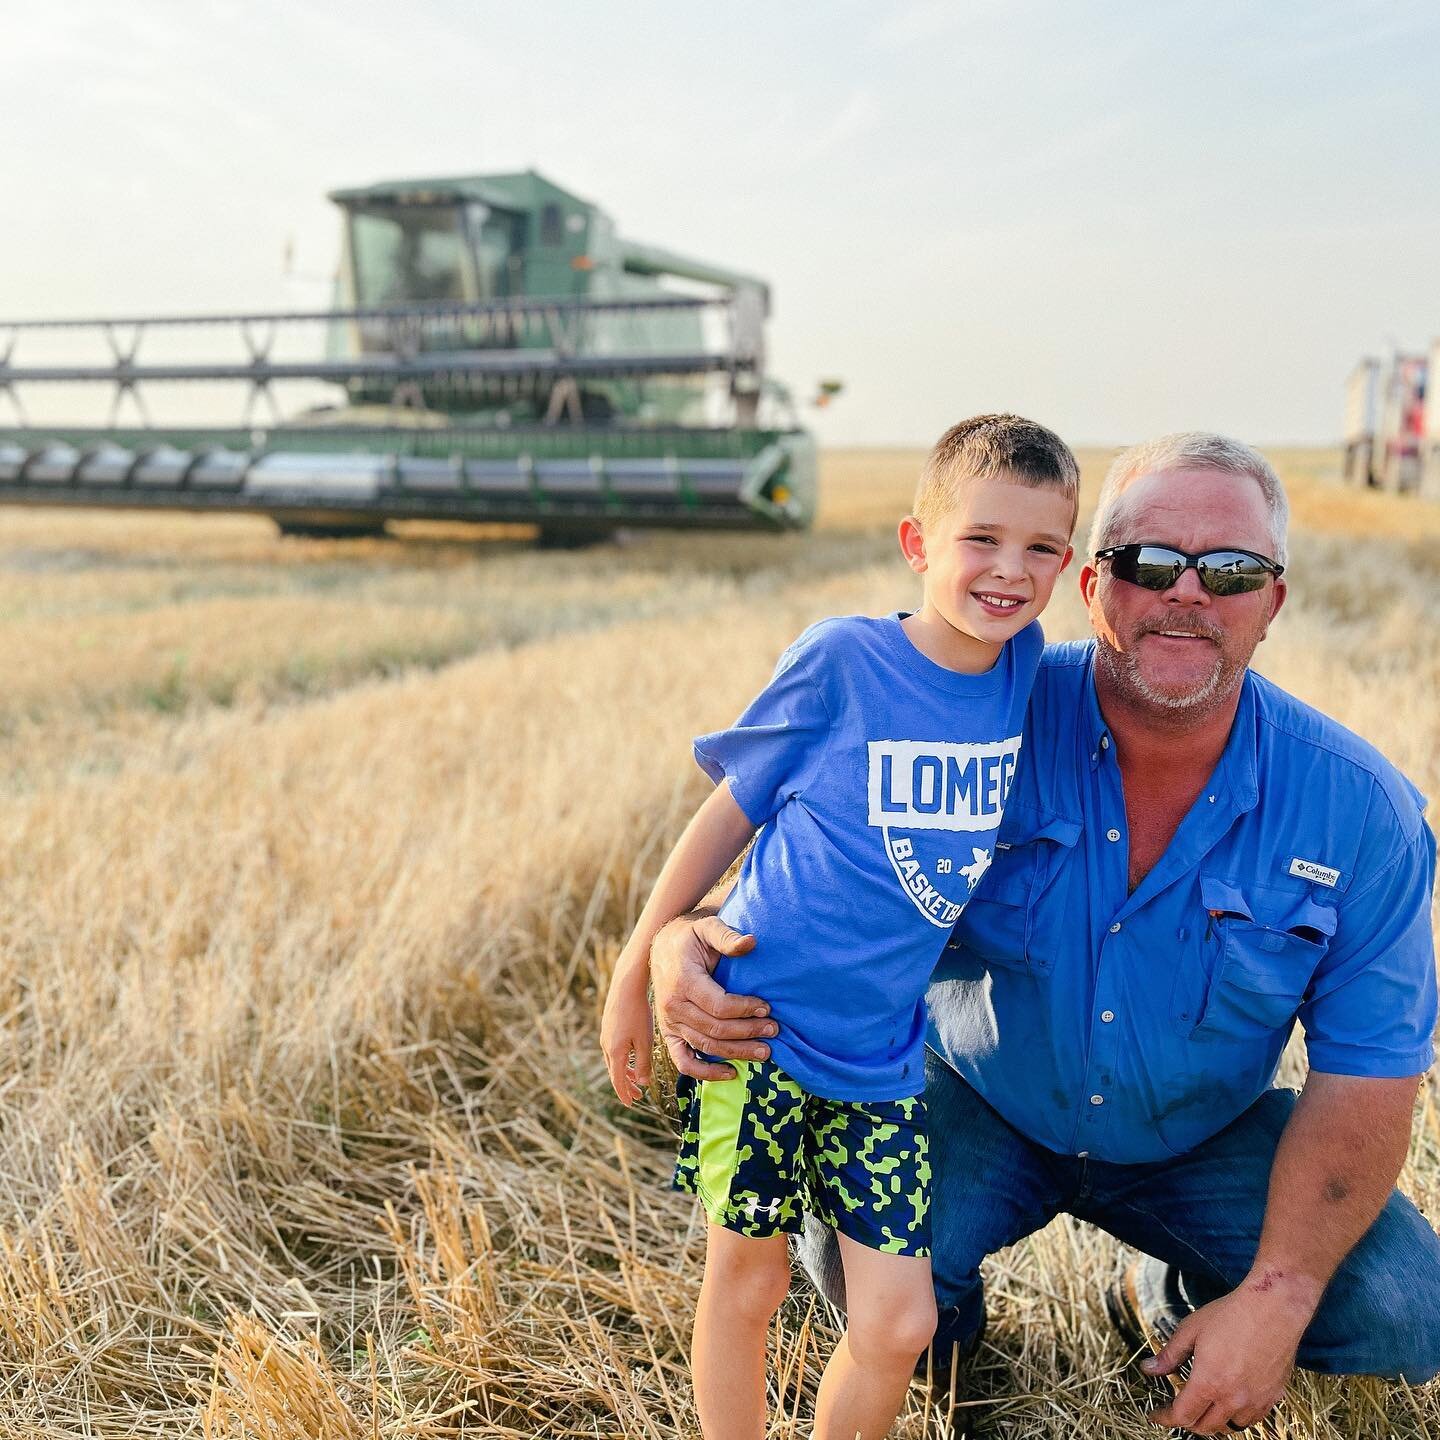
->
xmin=690 ymin=1225 xmax=791 ymax=1440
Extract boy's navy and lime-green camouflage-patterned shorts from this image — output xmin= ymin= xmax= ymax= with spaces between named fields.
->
xmin=675 ymin=1060 xmax=930 ymax=1256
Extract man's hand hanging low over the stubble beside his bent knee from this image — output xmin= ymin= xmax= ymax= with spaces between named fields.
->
xmin=1140 ymin=1276 xmax=1319 ymax=1436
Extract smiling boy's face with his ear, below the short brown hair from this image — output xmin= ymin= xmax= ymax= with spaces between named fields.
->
xmin=900 ymin=477 xmax=1074 ymax=674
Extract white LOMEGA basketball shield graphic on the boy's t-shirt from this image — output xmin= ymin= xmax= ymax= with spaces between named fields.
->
xmin=868 ymin=734 xmax=1020 ymax=929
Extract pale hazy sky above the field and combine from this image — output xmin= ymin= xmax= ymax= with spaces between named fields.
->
xmin=0 ymin=0 xmax=1440 ymax=445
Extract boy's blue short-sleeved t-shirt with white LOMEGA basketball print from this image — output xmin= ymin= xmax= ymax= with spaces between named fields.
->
xmin=696 ymin=613 xmax=1044 ymax=1100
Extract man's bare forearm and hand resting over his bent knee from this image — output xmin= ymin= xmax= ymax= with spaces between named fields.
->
xmin=1145 ymin=1071 xmax=1420 ymax=1434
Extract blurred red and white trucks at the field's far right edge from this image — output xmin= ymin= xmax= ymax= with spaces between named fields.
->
xmin=1344 ymin=340 xmax=1440 ymax=500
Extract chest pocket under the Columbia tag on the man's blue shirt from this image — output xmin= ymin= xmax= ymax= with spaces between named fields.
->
xmin=1172 ymin=876 xmax=1338 ymax=1040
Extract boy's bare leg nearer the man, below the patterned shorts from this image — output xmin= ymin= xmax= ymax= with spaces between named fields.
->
xmin=815 ymin=1236 xmax=935 ymax=1440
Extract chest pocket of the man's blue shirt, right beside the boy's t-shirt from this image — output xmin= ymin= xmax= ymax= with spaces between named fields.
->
xmin=956 ymin=805 xmax=1080 ymax=975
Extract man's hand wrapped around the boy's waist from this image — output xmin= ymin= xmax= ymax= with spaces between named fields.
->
xmin=649 ymin=914 xmax=779 ymax=1080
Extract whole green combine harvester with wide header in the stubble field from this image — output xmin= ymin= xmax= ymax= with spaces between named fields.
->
xmin=0 ymin=171 xmax=834 ymax=544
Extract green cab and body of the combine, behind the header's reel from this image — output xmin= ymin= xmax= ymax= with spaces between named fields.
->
xmin=330 ymin=171 xmax=783 ymax=426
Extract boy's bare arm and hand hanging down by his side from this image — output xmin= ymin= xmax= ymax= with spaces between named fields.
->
xmin=600 ymin=780 xmax=756 ymax=1104
